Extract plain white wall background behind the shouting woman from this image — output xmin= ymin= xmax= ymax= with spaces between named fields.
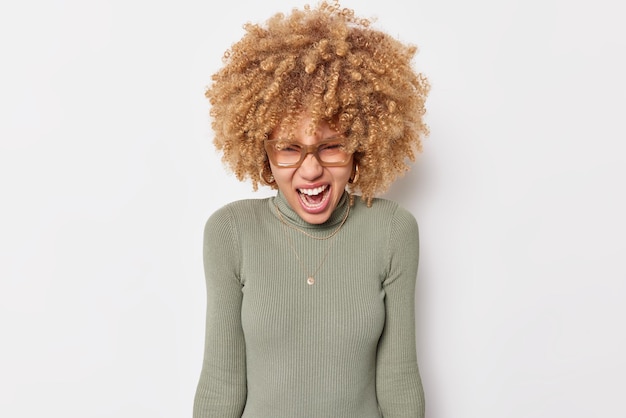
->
xmin=0 ymin=0 xmax=626 ymax=418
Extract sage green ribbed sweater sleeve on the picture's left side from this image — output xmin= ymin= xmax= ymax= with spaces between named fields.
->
xmin=193 ymin=206 xmax=247 ymax=418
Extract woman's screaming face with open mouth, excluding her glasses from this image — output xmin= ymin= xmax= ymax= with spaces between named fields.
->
xmin=270 ymin=115 xmax=353 ymax=224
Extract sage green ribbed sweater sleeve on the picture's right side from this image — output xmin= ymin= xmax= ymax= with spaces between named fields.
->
xmin=376 ymin=208 xmax=424 ymax=418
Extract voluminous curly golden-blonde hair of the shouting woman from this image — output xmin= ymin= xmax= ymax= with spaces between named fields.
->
xmin=205 ymin=1 xmax=429 ymax=204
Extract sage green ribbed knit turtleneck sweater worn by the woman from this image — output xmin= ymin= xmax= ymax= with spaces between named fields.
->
xmin=193 ymin=193 xmax=424 ymax=418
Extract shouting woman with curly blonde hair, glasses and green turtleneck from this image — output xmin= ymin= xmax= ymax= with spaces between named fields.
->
xmin=194 ymin=2 xmax=428 ymax=418
